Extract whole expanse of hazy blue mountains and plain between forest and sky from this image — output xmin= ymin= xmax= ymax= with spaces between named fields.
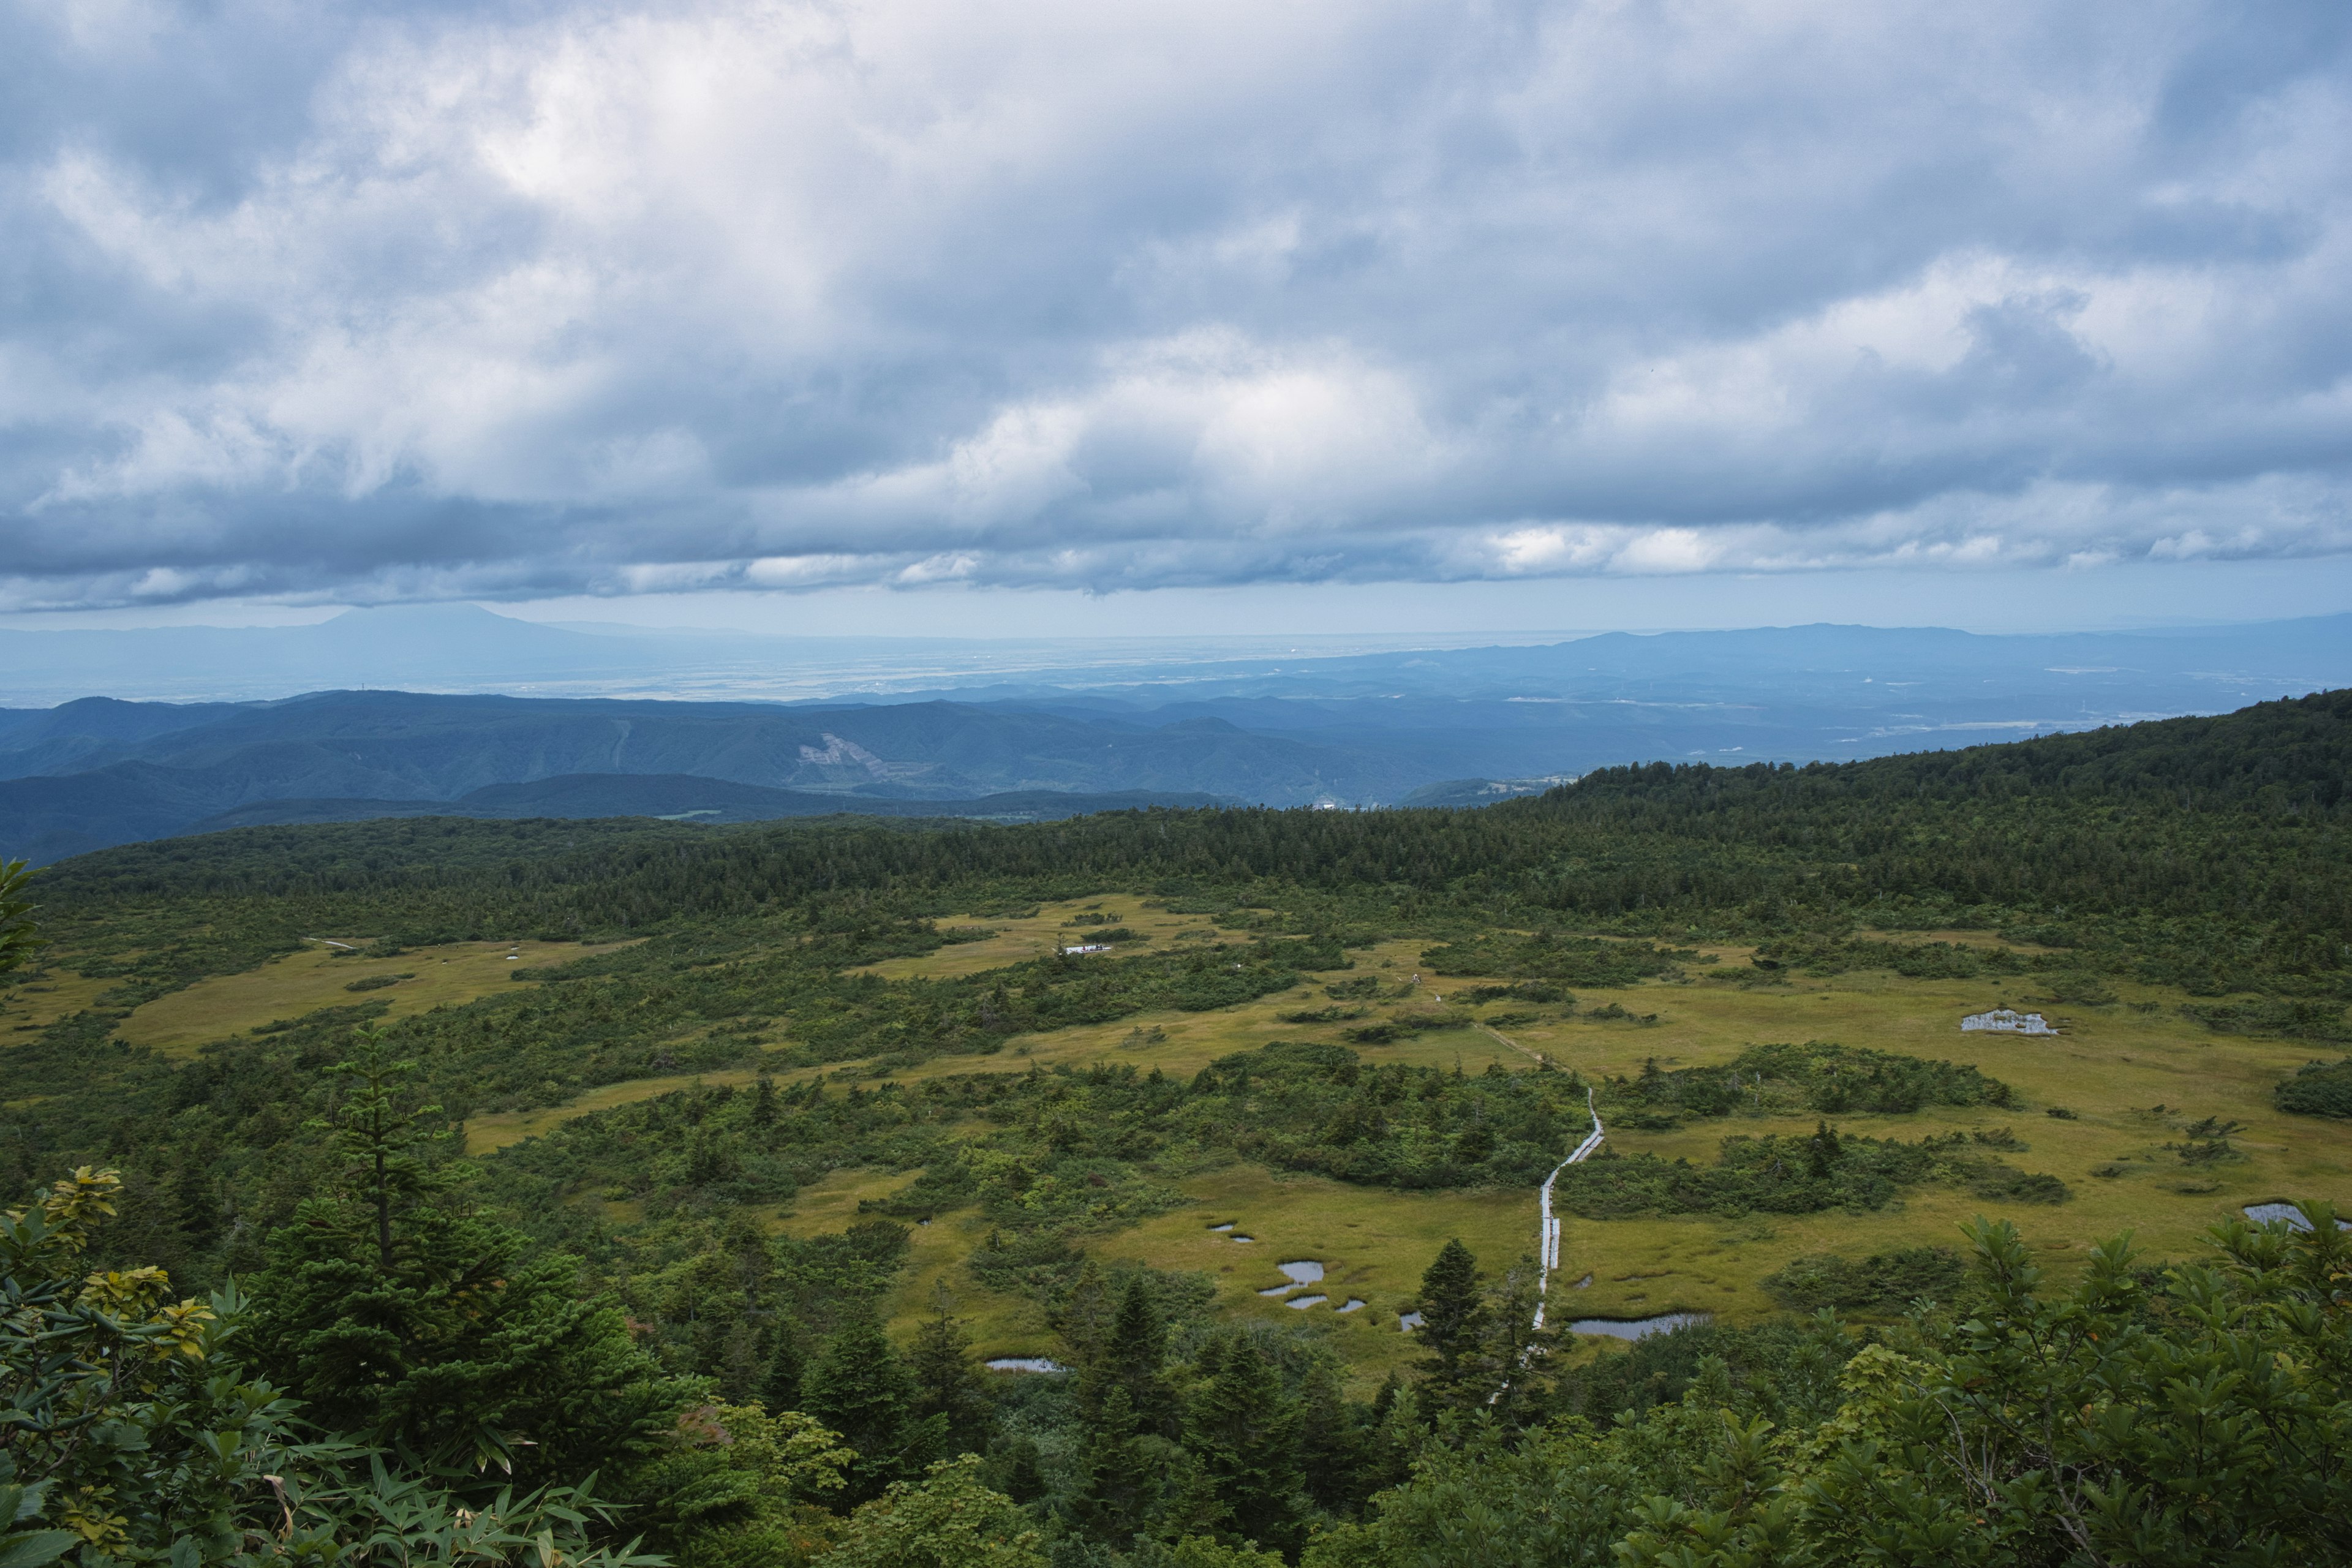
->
xmin=0 ymin=606 xmax=2352 ymax=861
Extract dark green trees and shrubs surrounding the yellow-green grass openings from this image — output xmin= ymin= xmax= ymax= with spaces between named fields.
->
xmin=0 ymin=693 xmax=2352 ymax=1568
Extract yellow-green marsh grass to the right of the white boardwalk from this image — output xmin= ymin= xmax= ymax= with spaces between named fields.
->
xmin=1512 ymin=973 xmax=2352 ymax=1316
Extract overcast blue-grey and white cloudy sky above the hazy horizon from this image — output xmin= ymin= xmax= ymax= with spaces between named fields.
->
xmin=0 ymin=0 xmax=2352 ymax=632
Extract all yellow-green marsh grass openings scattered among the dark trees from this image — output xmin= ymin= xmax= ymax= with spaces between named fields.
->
xmin=41 ymin=891 xmax=2314 ymax=1380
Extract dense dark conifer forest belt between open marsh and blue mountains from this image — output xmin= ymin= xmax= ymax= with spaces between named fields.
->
xmin=45 ymin=691 xmax=2352 ymax=995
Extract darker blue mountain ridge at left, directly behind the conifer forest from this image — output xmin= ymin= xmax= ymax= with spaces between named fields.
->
xmin=0 ymin=691 xmax=1404 ymax=861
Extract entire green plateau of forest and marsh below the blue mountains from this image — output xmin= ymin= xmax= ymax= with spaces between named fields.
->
xmin=0 ymin=693 xmax=2352 ymax=1563
